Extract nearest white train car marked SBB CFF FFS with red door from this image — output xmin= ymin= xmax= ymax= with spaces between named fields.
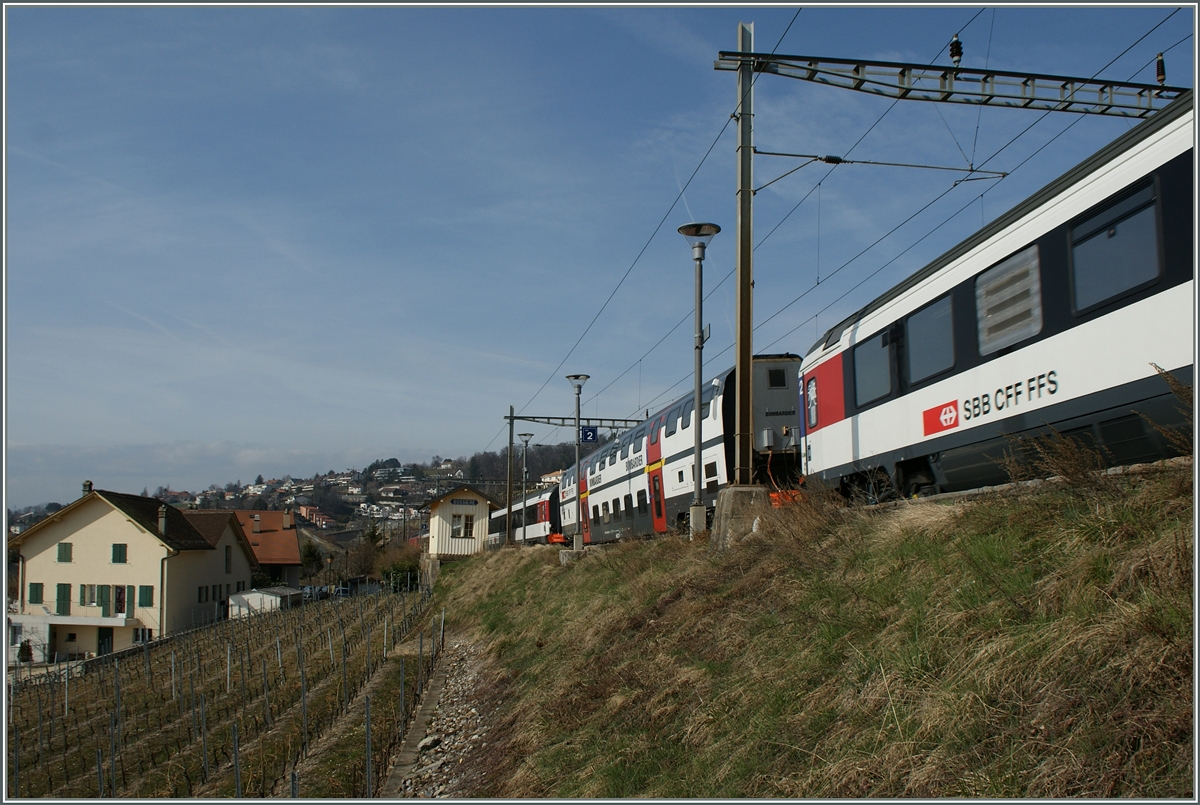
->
xmin=800 ymin=91 xmax=1195 ymax=499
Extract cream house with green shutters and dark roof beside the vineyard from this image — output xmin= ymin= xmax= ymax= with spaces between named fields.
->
xmin=8 ymin=482 xmax=257 ymax=661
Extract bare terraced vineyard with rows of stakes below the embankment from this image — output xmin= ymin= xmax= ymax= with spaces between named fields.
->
xmin=6 ymin=588 xmax=440 ymax=799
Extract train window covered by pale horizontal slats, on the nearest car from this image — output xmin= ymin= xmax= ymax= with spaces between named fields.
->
xmin=976 ymin=245 xmax=1042 ymax=355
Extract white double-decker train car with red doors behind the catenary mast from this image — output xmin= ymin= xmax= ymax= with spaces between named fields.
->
xmin=560 ymin=354 xmax=800 ymax=543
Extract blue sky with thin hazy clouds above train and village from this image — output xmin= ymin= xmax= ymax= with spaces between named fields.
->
xmin=5 ymin=5 xmax=1195 ymax=507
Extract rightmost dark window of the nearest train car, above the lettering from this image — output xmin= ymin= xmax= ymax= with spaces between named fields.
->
xmin=1070 ymin=187 xmax=1159 ymax=312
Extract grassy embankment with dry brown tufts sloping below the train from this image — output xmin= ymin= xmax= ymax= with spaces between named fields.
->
xmin=434 ymin=452 xmax=1195 ymax=798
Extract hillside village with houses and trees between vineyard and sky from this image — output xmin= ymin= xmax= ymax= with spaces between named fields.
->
xmin=7 ymin=445 xmax=595 ymax=661
